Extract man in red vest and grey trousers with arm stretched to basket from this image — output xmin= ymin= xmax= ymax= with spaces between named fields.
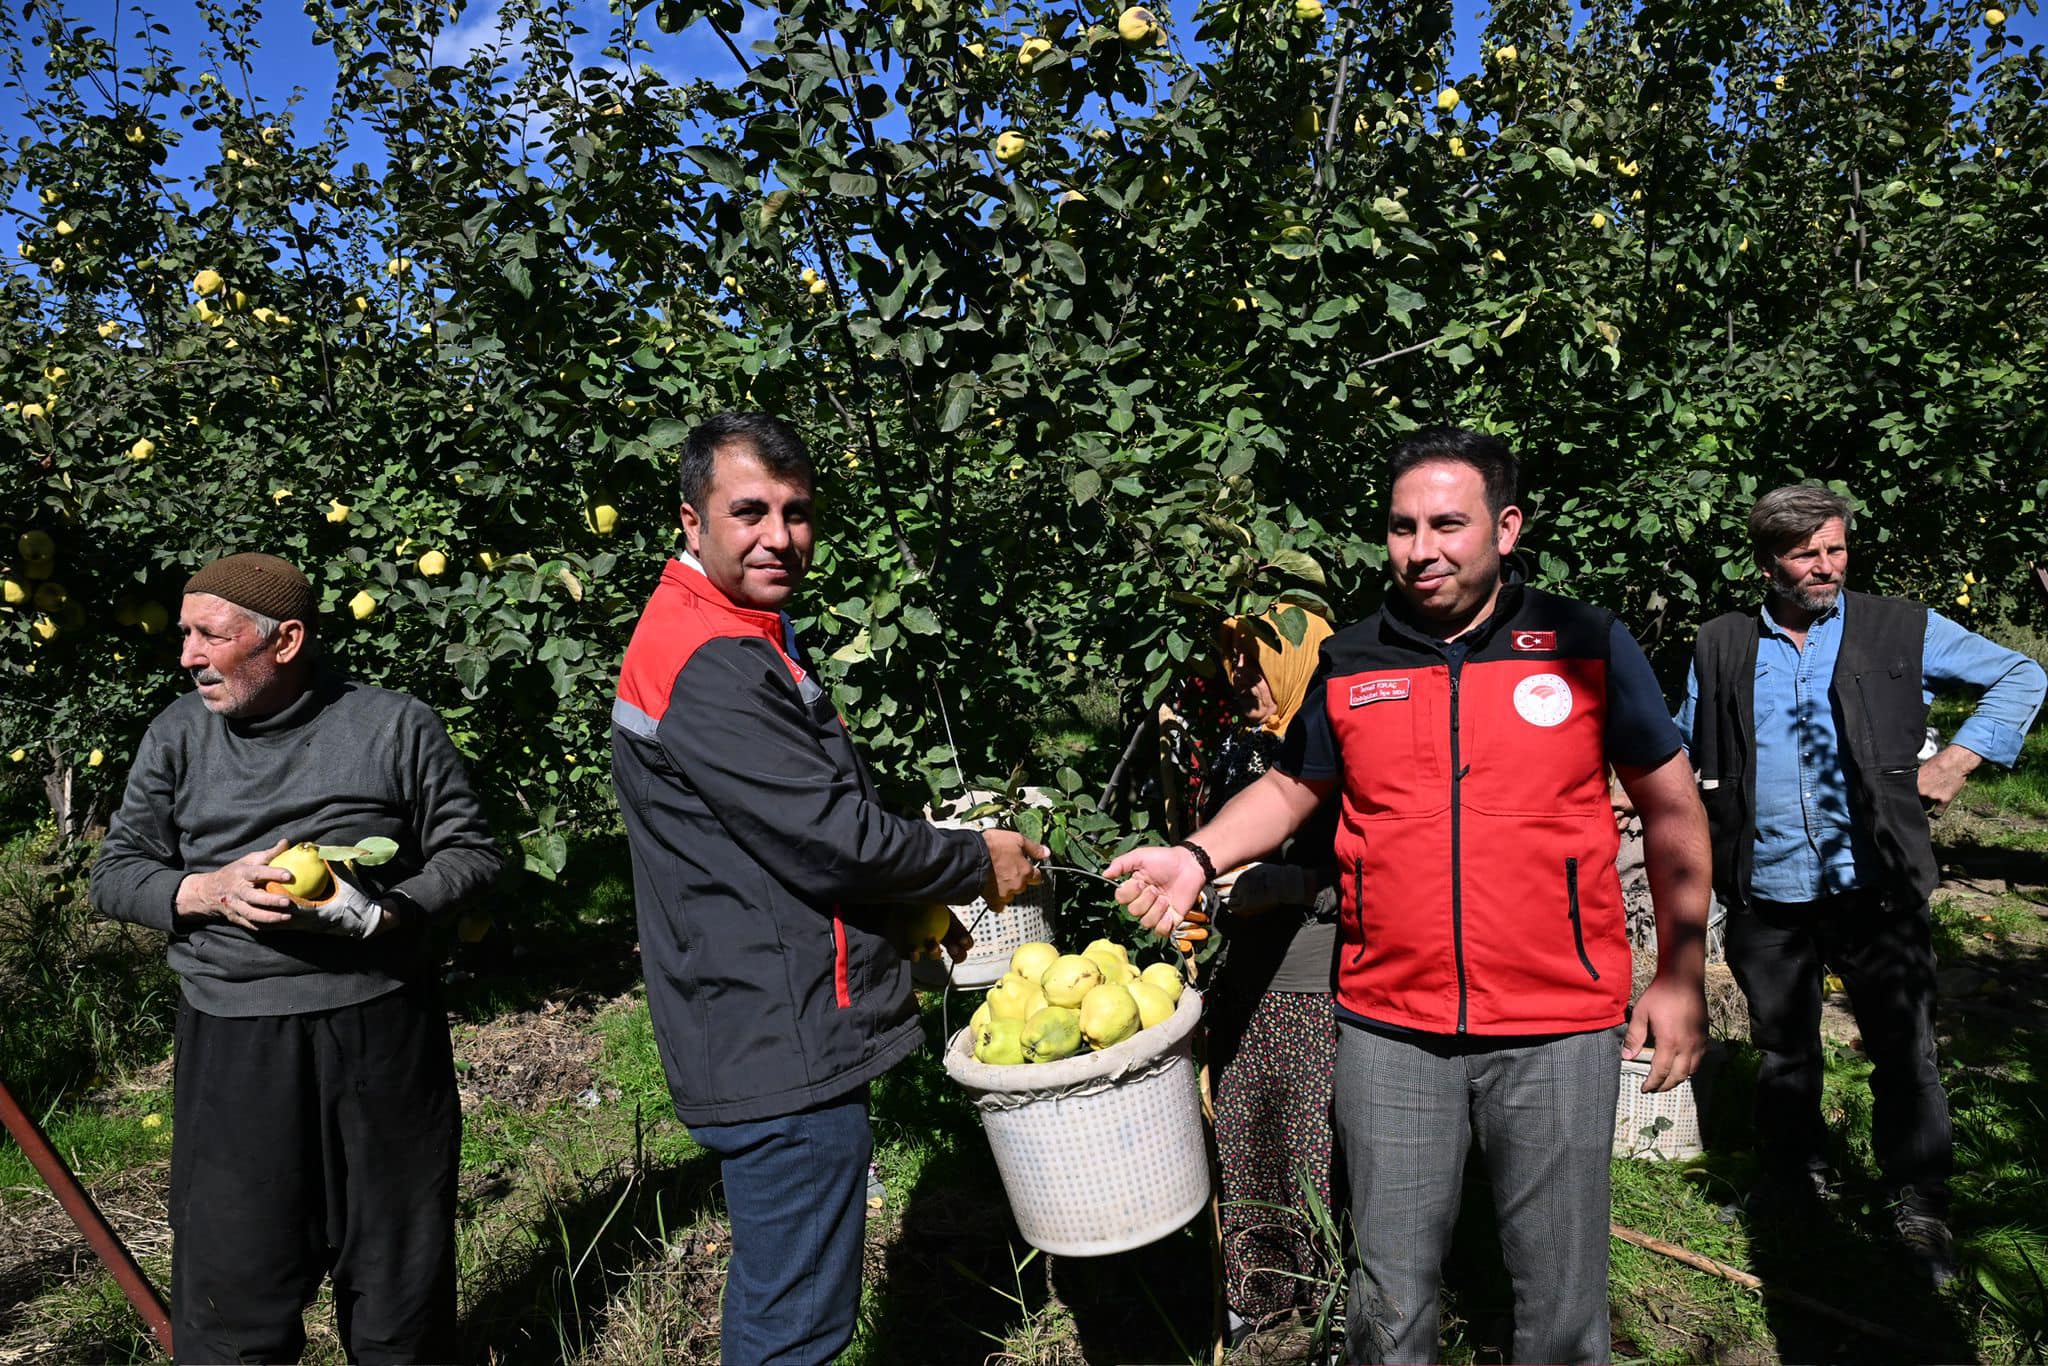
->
xmin=1110 ymin=430 xmax=1708 ymax=1362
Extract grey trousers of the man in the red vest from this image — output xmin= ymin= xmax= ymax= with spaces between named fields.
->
xmin=1333 ymin=1026 xmax=1624 ymax=1362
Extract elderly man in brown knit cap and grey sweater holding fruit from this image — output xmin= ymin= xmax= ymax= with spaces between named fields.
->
xmin=92 ymin=555 xmax=500 ymax=1362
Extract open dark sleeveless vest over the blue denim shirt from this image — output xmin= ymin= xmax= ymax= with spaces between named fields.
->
xmin=1692 ymin=592 xmax=1942 ymax=907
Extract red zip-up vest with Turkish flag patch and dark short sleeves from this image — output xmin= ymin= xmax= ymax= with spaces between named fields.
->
xmin=1280 ymin=580 xmax=1679 ymax=1036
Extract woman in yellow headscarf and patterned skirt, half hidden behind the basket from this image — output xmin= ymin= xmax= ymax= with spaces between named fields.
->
xmin=1200 ymin=606 xmax=1339 ymax=1337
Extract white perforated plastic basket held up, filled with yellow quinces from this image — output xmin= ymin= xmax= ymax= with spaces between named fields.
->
xmin=946 ymin=989 xmax=1208 ymax=1257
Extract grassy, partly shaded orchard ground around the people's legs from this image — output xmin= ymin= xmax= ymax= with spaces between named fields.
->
xmin=0 ymin=679 xmax=2048 ymax=1366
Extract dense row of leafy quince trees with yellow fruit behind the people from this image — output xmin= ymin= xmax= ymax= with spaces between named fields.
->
xmin=0 ymin=0 xmax=2048 ymax=866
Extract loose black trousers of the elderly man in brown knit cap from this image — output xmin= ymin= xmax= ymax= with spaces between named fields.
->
xmin=170 ymin=989 xmax=463 ymax=1362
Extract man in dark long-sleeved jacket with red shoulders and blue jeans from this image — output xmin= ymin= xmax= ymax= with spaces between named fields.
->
xmin=612 ymin=414 xmax=1047 ymax=1366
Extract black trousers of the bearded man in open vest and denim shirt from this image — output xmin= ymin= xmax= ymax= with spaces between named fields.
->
xmin=1729 ymin=891 xmax=1954 ymax=1206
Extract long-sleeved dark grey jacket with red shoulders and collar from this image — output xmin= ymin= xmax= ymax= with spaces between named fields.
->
xmin=612 ymin=559 xmax=989 ymax=1124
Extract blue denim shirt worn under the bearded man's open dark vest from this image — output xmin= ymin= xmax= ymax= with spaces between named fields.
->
xmin=1673 ymin=598 xmax=2048 ymax=901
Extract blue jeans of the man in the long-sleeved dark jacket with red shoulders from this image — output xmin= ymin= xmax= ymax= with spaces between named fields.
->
xmin=690 ymin=1087 xmax=874 ymax=1366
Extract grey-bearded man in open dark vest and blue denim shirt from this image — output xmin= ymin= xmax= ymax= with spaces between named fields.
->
xmin=1677 ymin=485 xmax=2048 ymax=1284
